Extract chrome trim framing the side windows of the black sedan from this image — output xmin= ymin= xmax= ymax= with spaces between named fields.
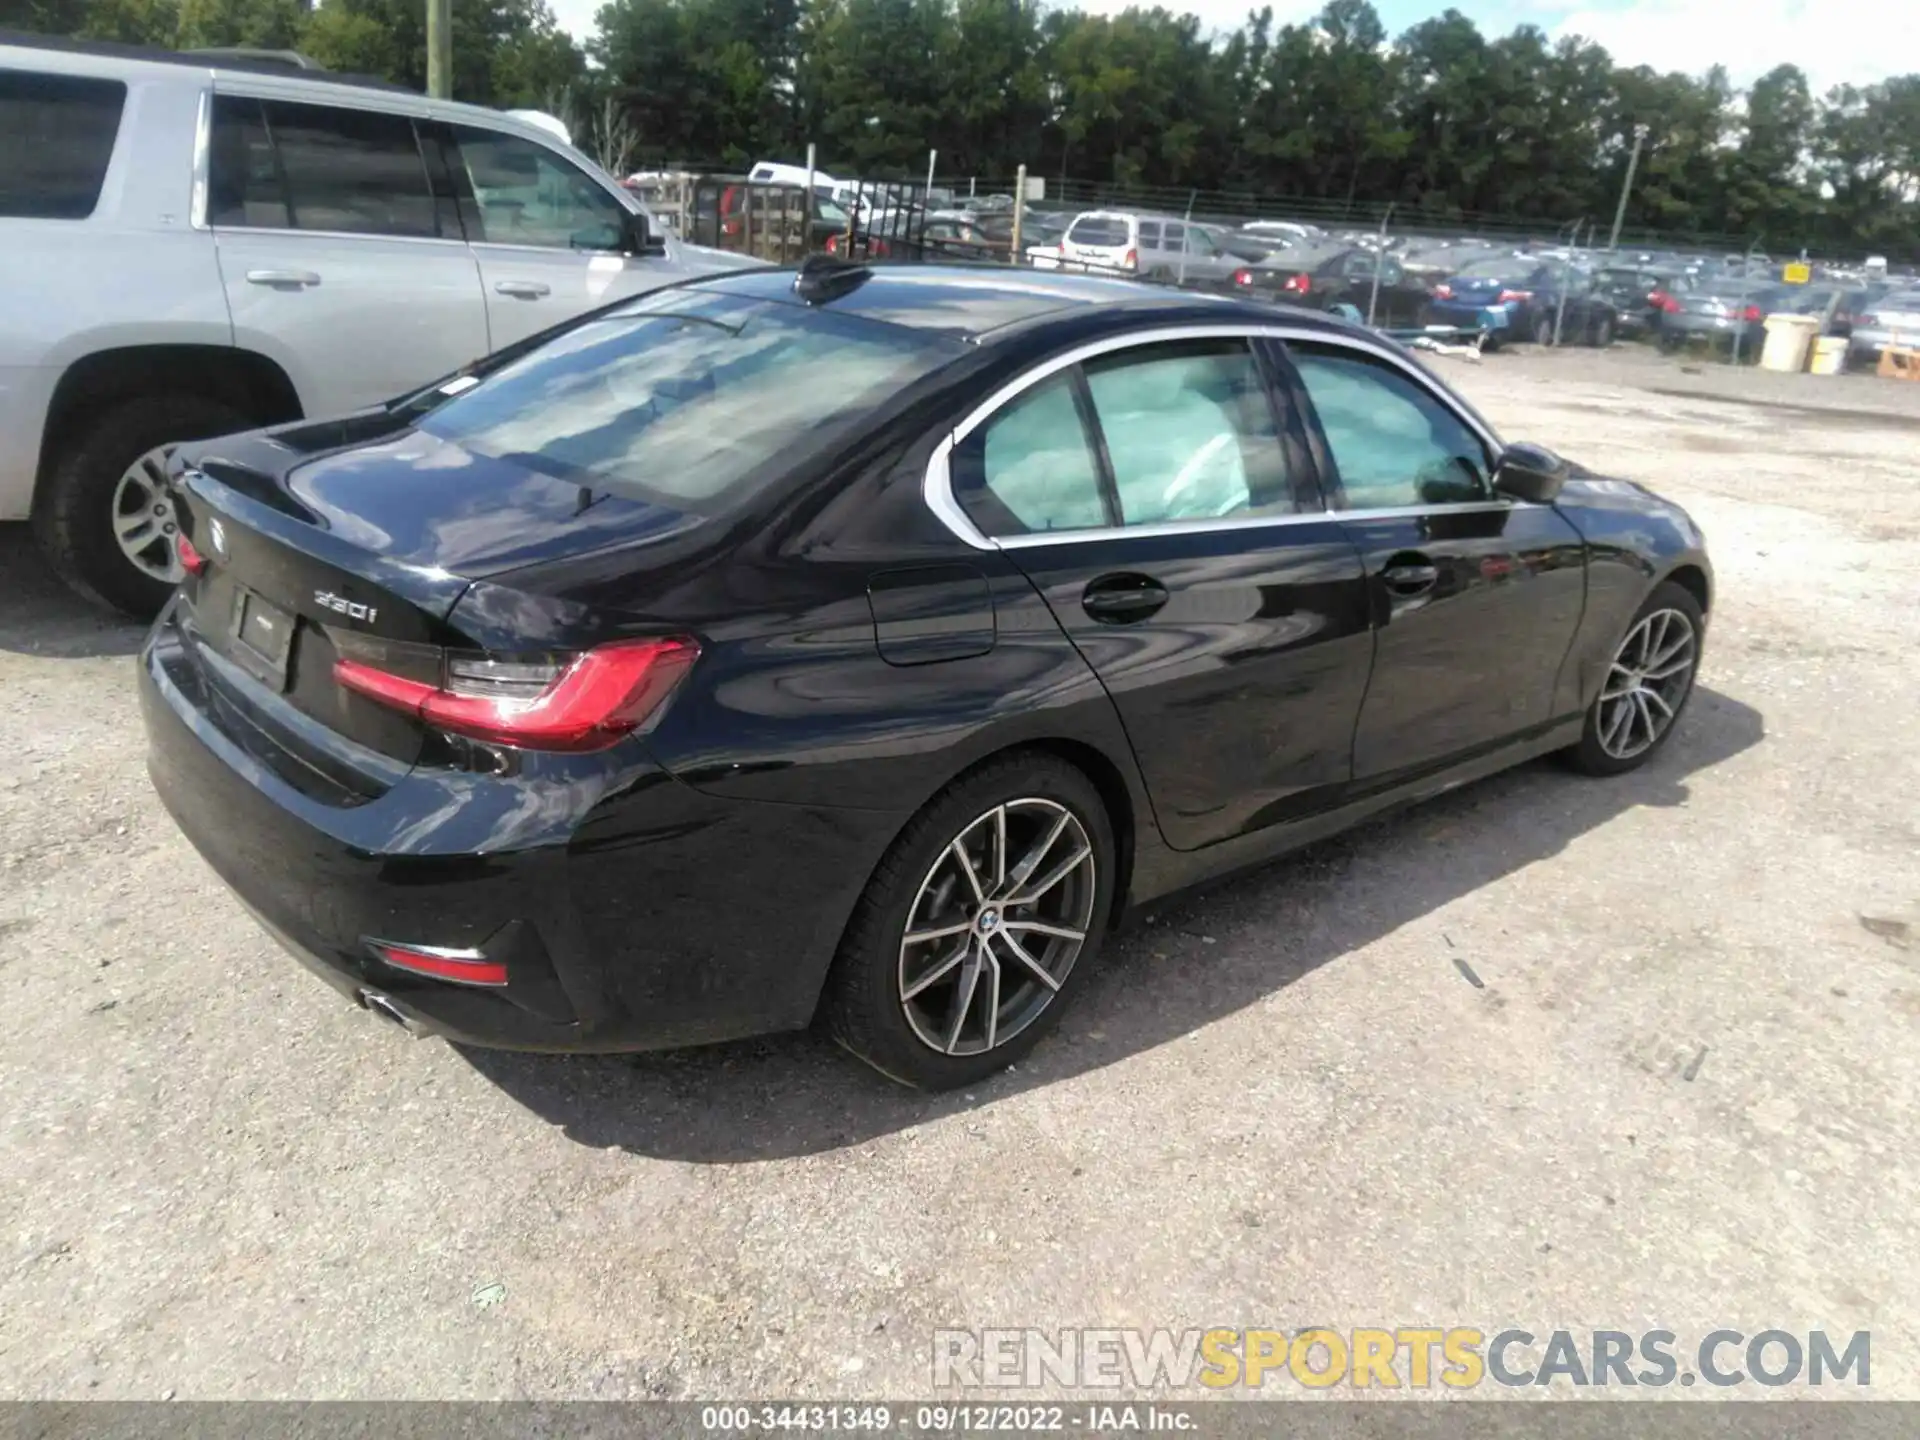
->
xmin=920 ymin=324 xmax=1530 ymax=551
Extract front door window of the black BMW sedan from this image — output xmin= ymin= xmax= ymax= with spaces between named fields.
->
xmin=1290 ymin=344 xmax=1494 ymax=511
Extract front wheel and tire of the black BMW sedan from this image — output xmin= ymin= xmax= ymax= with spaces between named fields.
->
xmin=1563 ymin=580 xmax=1707 ymax=776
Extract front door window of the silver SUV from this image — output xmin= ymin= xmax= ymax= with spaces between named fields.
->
xmin=453 ymin=125 xmax=625 ymax=250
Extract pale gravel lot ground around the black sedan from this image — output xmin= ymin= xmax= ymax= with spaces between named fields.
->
xmin=0 ymin=341 xmax=1920 ymax=1398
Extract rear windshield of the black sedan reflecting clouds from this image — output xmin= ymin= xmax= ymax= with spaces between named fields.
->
xmin=420 ymin=290 xmax=964 ymax=515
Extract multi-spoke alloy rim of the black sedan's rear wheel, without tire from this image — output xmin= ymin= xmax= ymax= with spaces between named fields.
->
xmin=899 ymin=797 xmax=1098 ymax=1056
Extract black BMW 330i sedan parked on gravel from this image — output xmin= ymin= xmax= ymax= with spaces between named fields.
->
xmin=140 ymin=261 xmax=1711 ymax=1089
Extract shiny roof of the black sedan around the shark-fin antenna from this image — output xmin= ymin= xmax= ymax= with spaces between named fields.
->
xmin=693 ymin=263 xmax=1374 ymax=344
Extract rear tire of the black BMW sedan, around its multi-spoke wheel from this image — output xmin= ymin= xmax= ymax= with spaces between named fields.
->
xmin=822 ymin=751 xmax=1117 ymax=1091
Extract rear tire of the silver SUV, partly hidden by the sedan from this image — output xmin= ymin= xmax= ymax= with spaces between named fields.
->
xmin=33 ymin=394 xmax=248 ymax=620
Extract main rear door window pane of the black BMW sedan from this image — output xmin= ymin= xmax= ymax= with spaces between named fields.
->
xmin=1087 ymin=340 xmax=1294 ymax=524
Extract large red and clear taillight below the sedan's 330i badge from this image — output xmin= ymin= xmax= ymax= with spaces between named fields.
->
xmin=334 ymin=637 xmax=701 ymax=751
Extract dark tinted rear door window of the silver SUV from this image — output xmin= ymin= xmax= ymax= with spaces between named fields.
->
xmin=207 ymin=94 xmax=440 ymax=238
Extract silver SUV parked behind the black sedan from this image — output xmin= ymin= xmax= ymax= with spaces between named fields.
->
xmin=0 ymin=35 xmax=741 ymax=614
